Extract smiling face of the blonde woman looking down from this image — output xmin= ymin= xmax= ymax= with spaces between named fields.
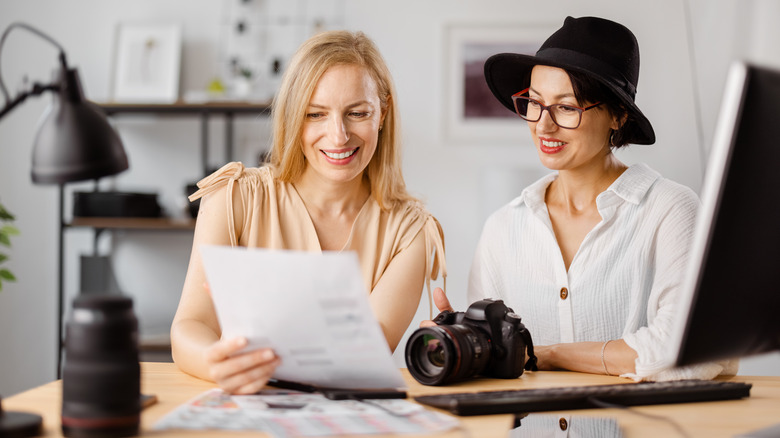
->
xmin=302 ymin=64 xmax=384 ymax=182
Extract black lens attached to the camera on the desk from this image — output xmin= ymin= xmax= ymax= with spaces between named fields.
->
xmin=406 ymin=324 xmax=490 ymax=385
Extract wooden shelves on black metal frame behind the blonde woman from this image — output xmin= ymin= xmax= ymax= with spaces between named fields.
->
xmin=57 ymin=101 xmax=270 ymax=376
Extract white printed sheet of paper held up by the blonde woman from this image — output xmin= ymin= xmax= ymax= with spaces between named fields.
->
xmin=201 ymin=245 xmax=405 ymax=389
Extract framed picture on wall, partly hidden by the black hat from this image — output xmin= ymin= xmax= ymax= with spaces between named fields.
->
xmin=442 ymin=23 xmax=557 ymax=144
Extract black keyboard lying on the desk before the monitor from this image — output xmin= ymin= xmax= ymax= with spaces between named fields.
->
xmin=414 ymin=380 xmax=752 ymax=415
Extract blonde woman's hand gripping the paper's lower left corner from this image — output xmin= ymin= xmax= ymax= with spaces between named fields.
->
xmin=204 ymin=337 xmax=281 ymax=394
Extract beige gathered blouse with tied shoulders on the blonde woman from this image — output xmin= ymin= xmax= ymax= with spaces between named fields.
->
xmin=190 ymin=162 xmax=447 ymax=314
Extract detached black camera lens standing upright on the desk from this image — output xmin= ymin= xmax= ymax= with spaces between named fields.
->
xmin=62 ymin=295 xmax=141 ymax=437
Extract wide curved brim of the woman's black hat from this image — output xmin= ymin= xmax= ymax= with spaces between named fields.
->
xmin=485 ymin=53 xmax=655 ymax=145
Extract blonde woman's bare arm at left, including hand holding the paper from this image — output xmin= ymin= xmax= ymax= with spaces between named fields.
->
xmin=171 ymin=188 xmax=279 ymax=394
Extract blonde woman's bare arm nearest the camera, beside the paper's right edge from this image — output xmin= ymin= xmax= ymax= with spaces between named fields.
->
xmin=369 ymin=230 xmax=427 ymax=351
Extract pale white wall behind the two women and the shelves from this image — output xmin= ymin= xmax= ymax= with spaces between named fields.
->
xmin=0 ymin=0 xmax=780 ymax=396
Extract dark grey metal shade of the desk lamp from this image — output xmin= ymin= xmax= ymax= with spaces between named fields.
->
xmin=32 ymin=69 xmax=128 ymax=184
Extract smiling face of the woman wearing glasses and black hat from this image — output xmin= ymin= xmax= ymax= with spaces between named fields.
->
xmin=528 ymin=65 xmax=619 ymax=170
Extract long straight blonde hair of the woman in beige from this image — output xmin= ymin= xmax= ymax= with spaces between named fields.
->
xmin=269 ymin=30 xmax=415 ymax=209
